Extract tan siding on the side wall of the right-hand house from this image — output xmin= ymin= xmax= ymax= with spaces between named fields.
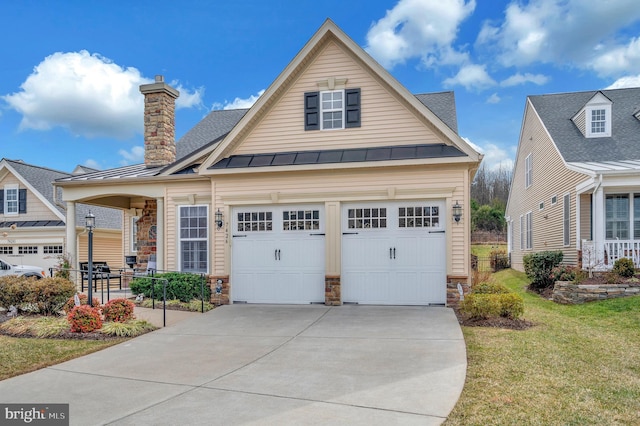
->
xmin=507 ymin=103 xmax=584 ymax=270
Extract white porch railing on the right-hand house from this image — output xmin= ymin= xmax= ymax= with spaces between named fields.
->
xmin=582 ymin=240 xmax=640 ymax=270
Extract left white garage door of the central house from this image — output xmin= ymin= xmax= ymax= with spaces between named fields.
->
xmin=231 ymin=205 xmax=325 ymax=303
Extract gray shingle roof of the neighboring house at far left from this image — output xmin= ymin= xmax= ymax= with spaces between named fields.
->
xmin=4 ymin=158 xmax=122 ymax=229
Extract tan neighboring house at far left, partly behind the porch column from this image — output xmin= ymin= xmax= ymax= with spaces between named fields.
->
xmin=0 ymin=158 xmax=123 ymax=273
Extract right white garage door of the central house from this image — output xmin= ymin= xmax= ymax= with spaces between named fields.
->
xmin=342 ymin=201 xmax=447 ymax=305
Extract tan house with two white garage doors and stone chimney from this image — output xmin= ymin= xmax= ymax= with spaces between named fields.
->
xmin=56 ymin=20 xmax=481 ymax=305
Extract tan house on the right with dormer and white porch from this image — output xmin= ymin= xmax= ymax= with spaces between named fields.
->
xmin=506 ymin=88 xmax=640 ymax=270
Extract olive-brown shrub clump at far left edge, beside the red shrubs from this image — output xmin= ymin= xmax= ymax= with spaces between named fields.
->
xmin=0 ymin=276 xmax=76 ymax=315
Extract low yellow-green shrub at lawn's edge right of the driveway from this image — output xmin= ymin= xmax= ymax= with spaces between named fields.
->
xmin=460 ymin=293 xmax=524 ymax=319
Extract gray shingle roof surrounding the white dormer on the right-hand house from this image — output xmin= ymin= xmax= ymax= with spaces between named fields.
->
xmin=525 ymin=88 xmax=640 ymax=162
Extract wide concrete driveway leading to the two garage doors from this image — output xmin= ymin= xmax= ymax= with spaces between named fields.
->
xmin=0 ymin=305 xmax=467 ymax=425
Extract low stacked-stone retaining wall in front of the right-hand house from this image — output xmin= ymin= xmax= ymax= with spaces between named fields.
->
xmin=553 ymin=281 xmax=640 ymax=305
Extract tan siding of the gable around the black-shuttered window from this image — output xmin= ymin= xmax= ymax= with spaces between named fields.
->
xmin=234 ymin=42 xmax=442 ymax=155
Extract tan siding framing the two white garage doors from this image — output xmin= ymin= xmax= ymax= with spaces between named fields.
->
xmin=212 ymin=165 xmax=470 ymax=276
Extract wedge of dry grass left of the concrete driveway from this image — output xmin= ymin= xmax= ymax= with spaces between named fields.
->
xmin=0 ymin=335 xmax=126 ymax=380
